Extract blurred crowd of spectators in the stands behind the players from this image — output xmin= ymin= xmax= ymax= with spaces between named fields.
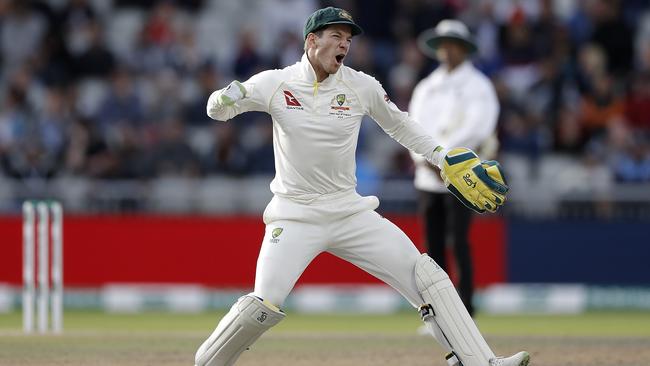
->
xmin=0 ymin=0 xmax=650 ymax=182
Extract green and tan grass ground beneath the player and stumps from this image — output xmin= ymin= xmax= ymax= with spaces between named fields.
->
xmin=0 ymin=312 xmax=650 ymax=366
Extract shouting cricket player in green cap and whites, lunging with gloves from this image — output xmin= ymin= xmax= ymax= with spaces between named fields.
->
xmin=195 ymin=7 xmax=529 ymax=366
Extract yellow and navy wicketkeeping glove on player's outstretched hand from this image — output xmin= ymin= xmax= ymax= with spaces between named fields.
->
xmin=440 ymin=147 xmax=508 ymax=213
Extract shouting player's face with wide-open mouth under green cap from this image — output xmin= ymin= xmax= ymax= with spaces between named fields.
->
xmin=307 ymin=24 xmax=352 ymax=81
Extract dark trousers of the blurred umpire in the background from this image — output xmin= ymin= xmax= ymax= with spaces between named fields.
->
xmin=419 ymin=191 xmax=474 ymax=315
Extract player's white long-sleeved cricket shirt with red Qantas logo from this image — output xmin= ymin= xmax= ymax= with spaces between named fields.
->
xmin=207 ymin=55 xmax=438 ymax=203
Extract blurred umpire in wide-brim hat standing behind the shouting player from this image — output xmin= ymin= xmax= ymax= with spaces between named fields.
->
xmin=409 ymin=20 xmax=499 ymax=315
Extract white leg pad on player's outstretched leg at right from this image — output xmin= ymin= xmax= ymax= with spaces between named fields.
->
xmin=415 ymin=254 xmax=494 ymax=366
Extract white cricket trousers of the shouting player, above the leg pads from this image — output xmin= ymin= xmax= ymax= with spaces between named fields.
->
xmin=254 ymin=190 xmax=424 ymax=307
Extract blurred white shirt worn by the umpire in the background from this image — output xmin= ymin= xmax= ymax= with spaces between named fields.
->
xmin=409 ymin=61 xmax=499 ymax=192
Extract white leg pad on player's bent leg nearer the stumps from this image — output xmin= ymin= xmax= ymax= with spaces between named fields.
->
xmin=194 ymin=294 xmax=286 ymax=366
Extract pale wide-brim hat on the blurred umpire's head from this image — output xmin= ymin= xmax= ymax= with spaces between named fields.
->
xmin=418 ymin=19 xmax=476 ymax=58
